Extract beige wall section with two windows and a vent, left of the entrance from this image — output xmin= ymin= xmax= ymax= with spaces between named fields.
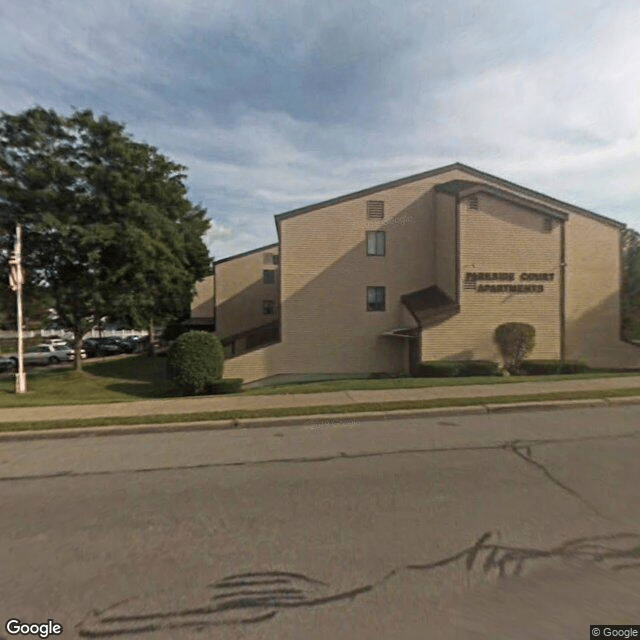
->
xmin=278 ymin=170 xmax=464 ymax=373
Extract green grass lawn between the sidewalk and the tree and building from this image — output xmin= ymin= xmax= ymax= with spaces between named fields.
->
xmin=0 ymin=354 xmax=628 ymax=408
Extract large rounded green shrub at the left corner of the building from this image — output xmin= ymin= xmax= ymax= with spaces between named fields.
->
xmin=167 ymin=331 xmax=224 ymax=394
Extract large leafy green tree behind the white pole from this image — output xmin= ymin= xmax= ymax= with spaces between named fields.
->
xmin=0 ymin=107 xmax=210 ymax=368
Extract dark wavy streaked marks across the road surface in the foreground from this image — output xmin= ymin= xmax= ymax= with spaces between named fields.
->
xmin=77 ymin=532 xmax=640 ymax=638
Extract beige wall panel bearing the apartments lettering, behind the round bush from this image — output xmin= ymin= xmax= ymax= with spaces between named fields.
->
xmin=422 ymin=194 xmax=560 ymax=361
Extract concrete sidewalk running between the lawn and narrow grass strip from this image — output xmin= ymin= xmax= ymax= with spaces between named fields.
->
xmin=0 ymin=375 xmax=640 ymax=422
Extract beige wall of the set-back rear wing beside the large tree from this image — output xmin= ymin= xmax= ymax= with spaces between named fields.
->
xmin=215 ymin=246 xmax=279 ymax=339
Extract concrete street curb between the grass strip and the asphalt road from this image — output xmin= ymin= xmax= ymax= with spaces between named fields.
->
xmin=0 ymin=396 xmax=640 ymax=442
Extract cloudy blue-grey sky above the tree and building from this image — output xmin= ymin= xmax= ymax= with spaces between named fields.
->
xmin=0 ymin=0 xmax=640 ymax=259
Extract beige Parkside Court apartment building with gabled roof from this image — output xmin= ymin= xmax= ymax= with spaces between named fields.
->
xmin=194 ymin=163 xmax=640 ymax=381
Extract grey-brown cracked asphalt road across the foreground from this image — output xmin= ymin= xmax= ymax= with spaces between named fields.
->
xmin=0 ymin=406 xmax=640 ymax=640
